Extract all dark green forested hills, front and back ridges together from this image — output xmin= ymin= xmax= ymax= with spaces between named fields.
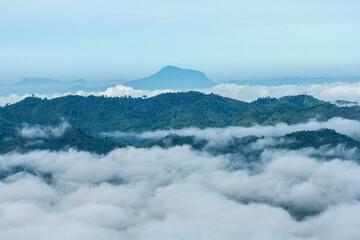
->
xmin=0 ymin=91 xmax=360 ymax=156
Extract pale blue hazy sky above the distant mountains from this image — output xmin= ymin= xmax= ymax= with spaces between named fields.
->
xmin=0 ymin=0 xmax=360 ymax=84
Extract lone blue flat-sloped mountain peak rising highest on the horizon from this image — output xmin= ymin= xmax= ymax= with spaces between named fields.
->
xmin=125 ymin=65 xmax=215 ymax=90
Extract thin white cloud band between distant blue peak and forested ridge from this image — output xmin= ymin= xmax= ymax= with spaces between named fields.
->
xmin=0 ymin=82 xmax=360 ymax=106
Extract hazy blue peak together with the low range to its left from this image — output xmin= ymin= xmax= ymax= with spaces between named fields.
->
xmin=0 ymin=66 xmax=216 ymax=96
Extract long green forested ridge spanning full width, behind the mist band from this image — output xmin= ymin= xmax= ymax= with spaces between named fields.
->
xmin=0 ymin=91 xmax=360 ymax=133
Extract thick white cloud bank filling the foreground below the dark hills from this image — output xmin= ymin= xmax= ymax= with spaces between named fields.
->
xmin=0 ymin=147 xmax=360 ymax=239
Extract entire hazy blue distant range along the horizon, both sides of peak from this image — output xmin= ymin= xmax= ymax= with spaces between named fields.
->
xmin=0 ymin=66 xmax=360 ymax=96
